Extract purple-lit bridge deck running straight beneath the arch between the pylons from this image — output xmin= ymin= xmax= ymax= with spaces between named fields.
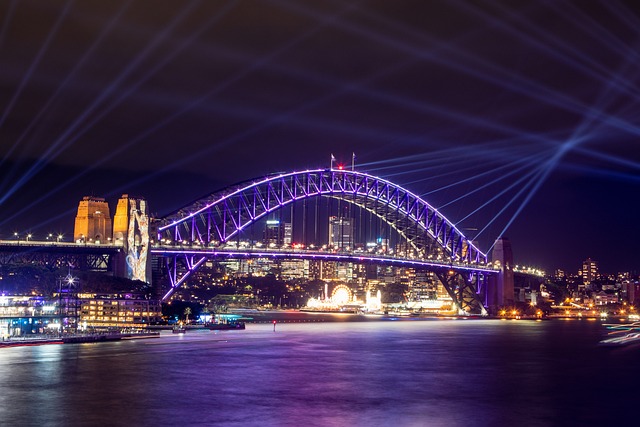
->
xmin=151 ymin=245 xmax=500 ymax=274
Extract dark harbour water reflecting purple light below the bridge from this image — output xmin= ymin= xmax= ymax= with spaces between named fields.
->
xmin=0 ymin=317 xmax=640 ymax=426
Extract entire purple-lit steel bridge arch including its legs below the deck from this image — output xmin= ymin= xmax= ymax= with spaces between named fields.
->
xmin=154 ymin=169 xmax=495 ymax=313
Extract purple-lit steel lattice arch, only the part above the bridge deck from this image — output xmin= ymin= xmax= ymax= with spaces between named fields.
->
xmin=158 ymin=169 xmax=487 ymax=264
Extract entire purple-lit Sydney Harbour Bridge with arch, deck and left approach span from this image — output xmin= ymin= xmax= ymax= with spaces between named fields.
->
xmin=0 ymin=168 xmax=513 ymax=315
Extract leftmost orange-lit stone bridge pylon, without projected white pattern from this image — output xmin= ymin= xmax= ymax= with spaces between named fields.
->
xmin=73 ymin=196 xmax=111 ymax=243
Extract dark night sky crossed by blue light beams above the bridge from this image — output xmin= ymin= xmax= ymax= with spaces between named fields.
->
xmin=0 ymin=0 xmax=640 ymax=273
